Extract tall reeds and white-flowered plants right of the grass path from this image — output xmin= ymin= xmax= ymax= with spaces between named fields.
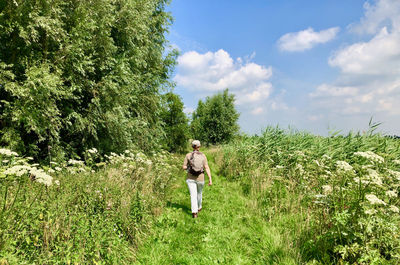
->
xmin=220 ymin=127 xmax=400 ymax=264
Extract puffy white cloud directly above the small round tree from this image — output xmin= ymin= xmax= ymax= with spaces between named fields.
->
xmin=174 ymin=49 xmax=272 ymax=104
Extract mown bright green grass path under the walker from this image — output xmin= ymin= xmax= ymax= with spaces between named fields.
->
xmin=137 ymin=150 xmax=297 ymax=265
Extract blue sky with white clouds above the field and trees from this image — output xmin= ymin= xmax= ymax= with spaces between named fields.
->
xmin=167 ymin=0 xmax=400 ymax=135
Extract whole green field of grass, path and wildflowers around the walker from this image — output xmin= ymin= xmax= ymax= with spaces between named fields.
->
xmin=0 ymin=128 xmax=400 ymax=264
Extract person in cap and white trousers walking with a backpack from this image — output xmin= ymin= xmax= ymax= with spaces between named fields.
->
xmin=182 ymin=140 xmax=212 ymax=218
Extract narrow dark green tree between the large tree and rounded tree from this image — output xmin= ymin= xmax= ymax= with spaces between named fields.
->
xmin=161 ymin=92 xmax=189 ymax=152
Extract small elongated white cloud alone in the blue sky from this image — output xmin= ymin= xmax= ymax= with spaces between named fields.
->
xmin=278 ymin=27 xmax=339 ymax=52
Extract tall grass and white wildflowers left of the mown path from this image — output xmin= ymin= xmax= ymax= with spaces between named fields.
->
xmin=0 ymin=149 xmax=177 ymax=264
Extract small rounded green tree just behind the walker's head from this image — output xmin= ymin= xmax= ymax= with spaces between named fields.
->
xmin=191 ymin=89 xmax=239 ymax=144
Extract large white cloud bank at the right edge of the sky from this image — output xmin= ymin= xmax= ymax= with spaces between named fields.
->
xmin=309 ymin=0 xmax=400 ymax=122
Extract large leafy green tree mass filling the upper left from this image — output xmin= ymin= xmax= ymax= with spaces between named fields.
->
xmin=0 ymin=0 xmax=176 ymax=157
